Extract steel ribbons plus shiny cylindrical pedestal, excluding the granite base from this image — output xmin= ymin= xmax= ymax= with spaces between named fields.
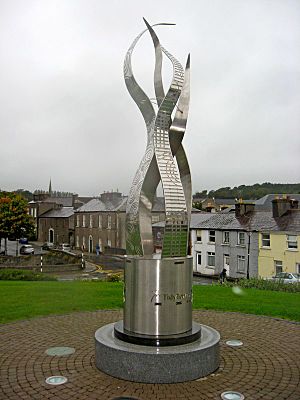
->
xmin=116 ymin=19 xmax=200 ymax=345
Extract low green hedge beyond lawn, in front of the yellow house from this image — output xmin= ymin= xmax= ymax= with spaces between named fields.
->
xmin=218 ymin=278 xmax=300 ymax=293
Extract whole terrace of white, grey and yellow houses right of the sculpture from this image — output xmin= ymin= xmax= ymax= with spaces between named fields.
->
xmin=190 ymin=198 xmax=300 ymax=278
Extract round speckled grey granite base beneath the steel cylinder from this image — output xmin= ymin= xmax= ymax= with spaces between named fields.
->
xmin=95 ymin=323 xmax=220 ymax=383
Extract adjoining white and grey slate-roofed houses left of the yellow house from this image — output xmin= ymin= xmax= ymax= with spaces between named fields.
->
xmin=190 ymin=204 xmax=258 ymax=278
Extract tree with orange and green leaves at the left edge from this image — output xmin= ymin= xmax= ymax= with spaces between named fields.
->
xmin=0 ymin=192 xmax=34 ymax=254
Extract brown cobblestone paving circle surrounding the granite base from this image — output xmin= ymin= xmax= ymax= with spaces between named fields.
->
xmin=0 ymin=311 xmax=300 ymax=400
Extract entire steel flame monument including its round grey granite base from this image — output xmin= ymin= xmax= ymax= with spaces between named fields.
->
xmin=95 ymin=20 xmax=220 ymax=383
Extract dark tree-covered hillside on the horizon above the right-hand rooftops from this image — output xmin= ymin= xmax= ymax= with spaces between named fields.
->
xmin=193 ymin=182 xmax=300 ymax=200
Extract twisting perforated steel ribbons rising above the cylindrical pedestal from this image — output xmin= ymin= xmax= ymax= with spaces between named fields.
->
xmin=124 ymin=19 xmax=191 ymax=258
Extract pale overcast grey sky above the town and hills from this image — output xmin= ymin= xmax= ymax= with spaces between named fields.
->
xmin=0 ymin=0 xmax=300 ymax=196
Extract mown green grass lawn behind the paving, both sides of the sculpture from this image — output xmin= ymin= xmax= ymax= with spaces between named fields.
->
xmin=0 ymin=281 xmax=300 ymax=323
